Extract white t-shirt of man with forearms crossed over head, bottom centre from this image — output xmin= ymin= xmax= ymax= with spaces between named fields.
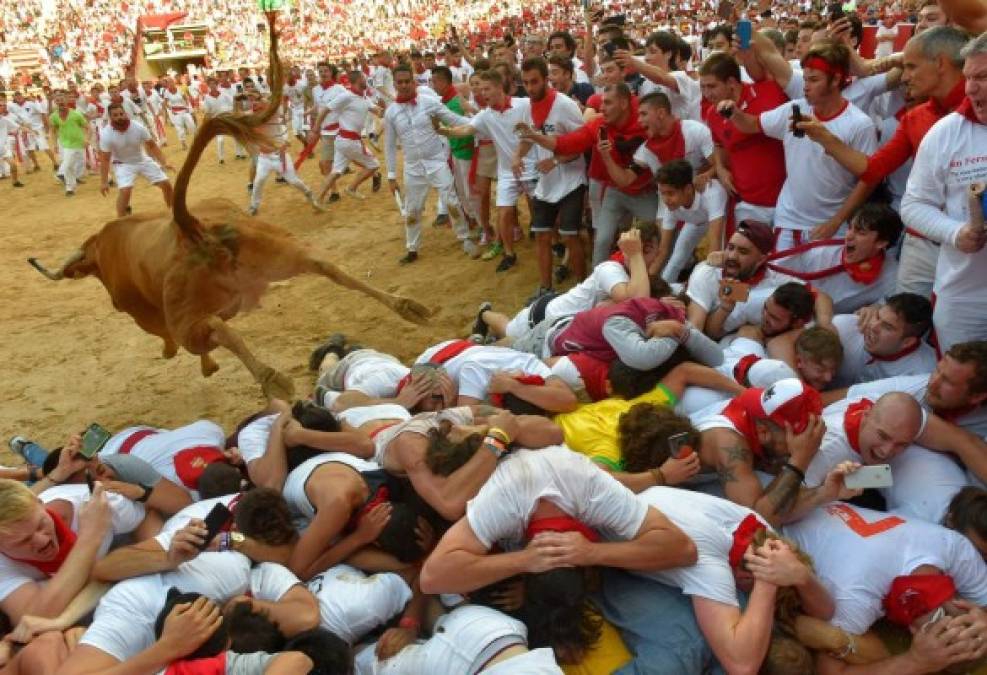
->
xmin=466 ymin=445 xmax=648 ymax=550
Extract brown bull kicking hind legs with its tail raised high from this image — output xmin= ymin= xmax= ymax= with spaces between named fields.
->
xmin=28 ymin=14 xmax=431 ymax=400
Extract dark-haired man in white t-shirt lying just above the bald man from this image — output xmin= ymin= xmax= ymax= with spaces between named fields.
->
xmin=833 ymin=293 xmax=936 ymax=387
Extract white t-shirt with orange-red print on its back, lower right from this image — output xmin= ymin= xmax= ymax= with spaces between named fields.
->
xmin=783 ymin=502 xmax=987 ymax=635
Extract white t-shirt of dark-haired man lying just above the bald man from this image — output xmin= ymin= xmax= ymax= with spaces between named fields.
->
xmin=833 ymin=314 xmax=937 ymax=387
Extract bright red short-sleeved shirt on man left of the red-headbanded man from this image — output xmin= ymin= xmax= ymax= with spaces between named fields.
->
xmin=705 ymin=80 xmax=788 ymax=206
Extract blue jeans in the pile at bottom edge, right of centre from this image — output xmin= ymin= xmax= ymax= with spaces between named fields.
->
xmin=598 ymin=569 xmax=723 ymax=675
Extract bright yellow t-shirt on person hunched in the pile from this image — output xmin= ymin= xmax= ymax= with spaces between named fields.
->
xmin=555 ymin=384 xmax=677 ymax=471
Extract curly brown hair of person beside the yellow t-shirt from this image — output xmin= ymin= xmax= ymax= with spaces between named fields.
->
xmin=617 ymin=403 xmax=699 ymax=473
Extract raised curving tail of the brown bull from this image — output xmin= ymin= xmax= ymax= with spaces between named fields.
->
xmin=172 ymin=12 xmax=284 ymax=244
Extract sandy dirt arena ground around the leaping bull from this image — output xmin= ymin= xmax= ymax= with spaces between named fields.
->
xmin=0 ymin=129 xmax=537 ymax=465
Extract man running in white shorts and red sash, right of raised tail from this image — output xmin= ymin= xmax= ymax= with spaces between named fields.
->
xmin=315 ymin=70 xmax=380 ymax=206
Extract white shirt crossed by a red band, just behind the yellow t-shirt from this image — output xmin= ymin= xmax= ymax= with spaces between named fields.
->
xmin=415 ymin=340 xmax=552 ymax=400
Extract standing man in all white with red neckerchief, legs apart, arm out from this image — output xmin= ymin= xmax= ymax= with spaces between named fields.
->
xmin=384 ymin=64 xmax=480 ymax=263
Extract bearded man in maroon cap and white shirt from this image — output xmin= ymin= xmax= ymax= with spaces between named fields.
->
xmin=686 ymin=220 xmax=832 ymax=339
